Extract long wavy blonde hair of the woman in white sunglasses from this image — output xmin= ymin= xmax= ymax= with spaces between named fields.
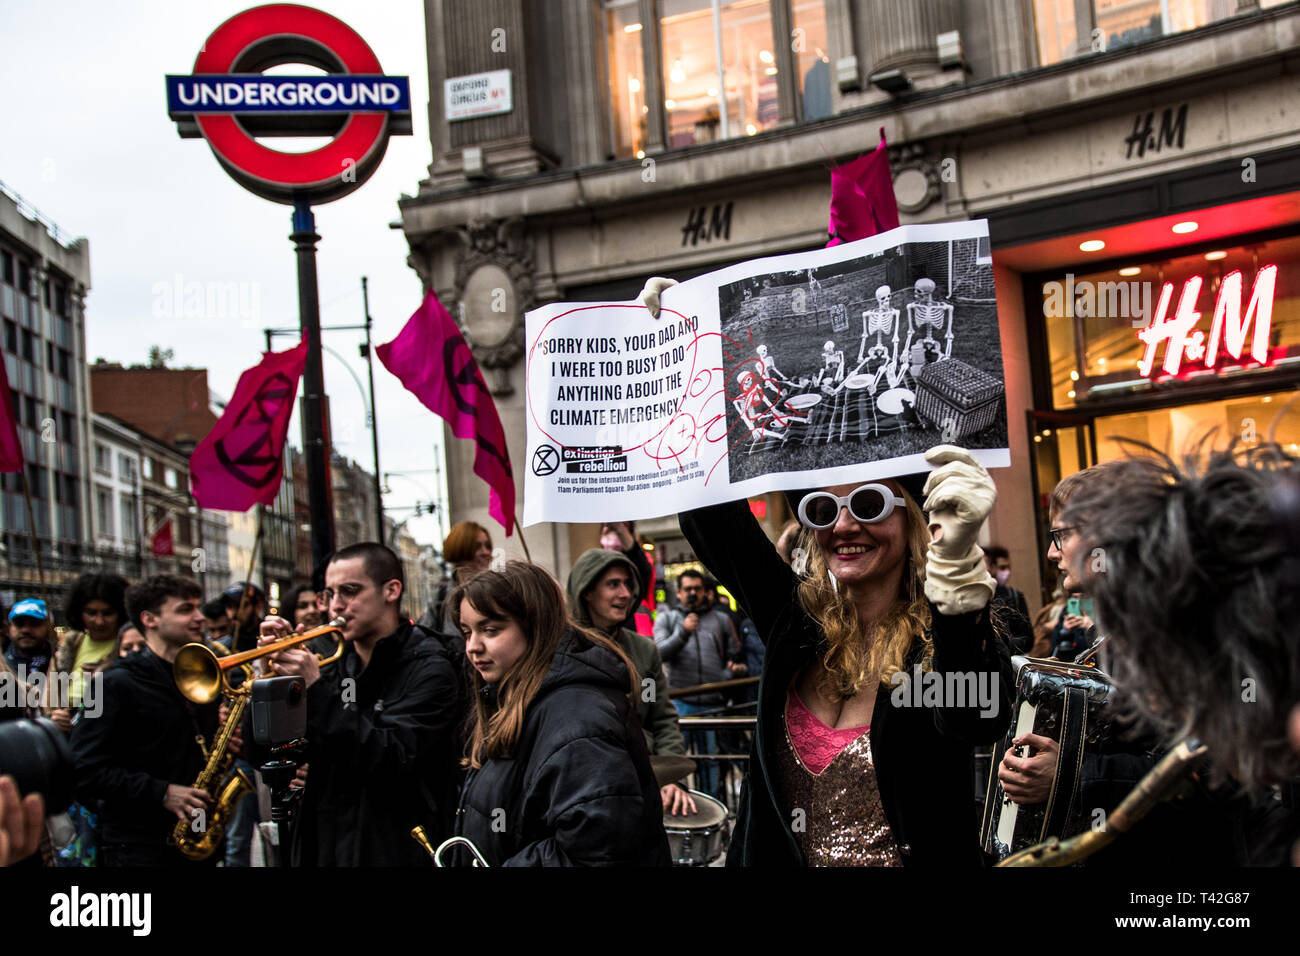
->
xmin=798 ymin=488 xmax=935 ymax=700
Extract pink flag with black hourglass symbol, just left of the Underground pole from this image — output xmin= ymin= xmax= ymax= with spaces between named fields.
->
xmin=190 ymin=339 xmax=307 ymax=511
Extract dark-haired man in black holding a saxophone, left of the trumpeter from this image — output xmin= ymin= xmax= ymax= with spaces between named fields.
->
xmin=72 ymin=575 xmax=221 ymax=866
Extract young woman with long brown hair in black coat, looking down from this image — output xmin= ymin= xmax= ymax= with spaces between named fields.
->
xmin=450 ymin=562 xmax=668 ymax=866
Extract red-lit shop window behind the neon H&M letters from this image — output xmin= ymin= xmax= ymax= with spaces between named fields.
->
xmin=1043 ymin=237 xmax=1300 ymax=408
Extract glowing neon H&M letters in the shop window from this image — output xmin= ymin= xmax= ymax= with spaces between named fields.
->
xmin=1138 ymin=265 xmax=1278 ymax=378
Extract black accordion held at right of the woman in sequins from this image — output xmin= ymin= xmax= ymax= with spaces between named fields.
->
xmin=980 ymin=656 xmax=1112 ymax=860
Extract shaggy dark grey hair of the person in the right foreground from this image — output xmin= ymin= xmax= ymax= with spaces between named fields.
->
xmin=1062 ymin=442 xmax=1300 ymax=792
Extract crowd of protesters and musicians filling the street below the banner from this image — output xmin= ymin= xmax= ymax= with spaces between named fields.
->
xmin=0 ymin=299 xmax=1300 ymax=869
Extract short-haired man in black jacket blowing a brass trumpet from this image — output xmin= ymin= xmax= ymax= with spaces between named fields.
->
xmin=261 ymin=542 xmax=465 ymax=866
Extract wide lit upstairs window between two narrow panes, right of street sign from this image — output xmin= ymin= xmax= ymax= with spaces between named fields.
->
xmin=659 ymin=0 xmax=783 ymax=148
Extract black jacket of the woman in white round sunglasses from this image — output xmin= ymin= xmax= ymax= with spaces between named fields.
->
xmin=679 ymin=501 xmax=1013 ymax=868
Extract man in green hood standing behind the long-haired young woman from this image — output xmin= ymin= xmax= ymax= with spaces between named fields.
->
xmin=568 ymin=548 xmax=696 ymax=816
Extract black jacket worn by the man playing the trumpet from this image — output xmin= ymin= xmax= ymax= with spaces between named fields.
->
xmin=294 ymin=620 xmax=465 ymax=866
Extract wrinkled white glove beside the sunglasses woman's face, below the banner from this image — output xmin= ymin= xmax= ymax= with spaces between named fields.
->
xmin=923 ymin=445 xmax=997 ymax=614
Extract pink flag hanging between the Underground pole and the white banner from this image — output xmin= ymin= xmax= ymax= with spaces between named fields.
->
xmin=374 ymin=290 xmax=515 ymax=537
